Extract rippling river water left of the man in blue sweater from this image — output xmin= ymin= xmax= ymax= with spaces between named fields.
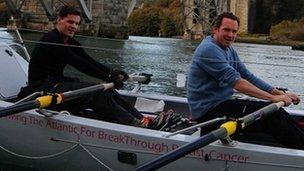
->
xmin=23 ymin=33 xmax=197 ymax=96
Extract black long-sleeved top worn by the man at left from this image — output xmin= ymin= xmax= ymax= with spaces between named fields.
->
xmin=28 ymin=29 xmax=110 ymax=85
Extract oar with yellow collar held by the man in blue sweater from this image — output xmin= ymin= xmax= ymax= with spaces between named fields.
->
xmin=135 ymin=102 xmax=284 ymax=171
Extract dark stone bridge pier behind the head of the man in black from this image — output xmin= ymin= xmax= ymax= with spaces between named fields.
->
xmin=0 ymin=0 xmax=136 ymax=38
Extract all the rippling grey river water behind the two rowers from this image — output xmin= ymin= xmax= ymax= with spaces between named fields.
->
xmin=2 ymin=30 xmax=304 ymax=109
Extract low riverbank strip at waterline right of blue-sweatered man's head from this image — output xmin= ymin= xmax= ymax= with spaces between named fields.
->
xmin=236 ymin=35 xmax=304 ymax=50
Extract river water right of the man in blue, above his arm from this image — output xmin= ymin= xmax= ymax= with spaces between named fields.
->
xmin=235 ymin=43 xmax=304 ymax=106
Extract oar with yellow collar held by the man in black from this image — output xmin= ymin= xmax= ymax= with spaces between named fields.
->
xmin=0 ymin=83 xmax=114 ymax=117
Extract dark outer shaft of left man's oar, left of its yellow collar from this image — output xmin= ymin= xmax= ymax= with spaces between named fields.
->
xmin=0 ymin=100 xmax=40 ymax=117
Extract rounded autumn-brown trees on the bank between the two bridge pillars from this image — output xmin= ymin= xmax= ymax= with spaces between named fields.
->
xmin=128 ymin=0 xmax=183 ymax=37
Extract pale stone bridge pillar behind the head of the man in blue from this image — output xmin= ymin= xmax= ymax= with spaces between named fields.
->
xmin=181 ymin=0 xmax=256 ymax=39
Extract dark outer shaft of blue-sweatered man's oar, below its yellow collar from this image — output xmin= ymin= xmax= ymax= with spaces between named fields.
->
xmin=135 ymin=128 xmax=227 ymax=171
